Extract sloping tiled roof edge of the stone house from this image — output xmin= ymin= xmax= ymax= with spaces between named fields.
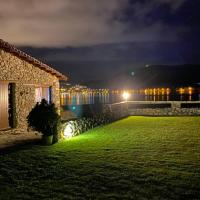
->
xmin=0 ymin=39 xmax=67 ymax=80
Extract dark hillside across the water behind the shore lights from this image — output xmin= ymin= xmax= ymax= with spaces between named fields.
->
xmin=83 ymin=65 xmax=200 ymax=89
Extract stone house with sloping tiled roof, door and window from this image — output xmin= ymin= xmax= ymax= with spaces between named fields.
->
xmin=0 ymin=39 xmax=67 ymax=131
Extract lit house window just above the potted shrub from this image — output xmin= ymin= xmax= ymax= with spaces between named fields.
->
xmin=35 ymin=87 xmax=52 ymax=103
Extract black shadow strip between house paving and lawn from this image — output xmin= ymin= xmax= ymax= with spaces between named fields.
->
xmin=0 ymin=138 xmax=41 ymax=155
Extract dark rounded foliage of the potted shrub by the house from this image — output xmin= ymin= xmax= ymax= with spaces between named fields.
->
xmin=27 ymin=99 xmax=61 ymax=142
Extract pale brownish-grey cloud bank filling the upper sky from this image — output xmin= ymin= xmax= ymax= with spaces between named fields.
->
xmin=0 ymin=0 xmax=189 ymax=47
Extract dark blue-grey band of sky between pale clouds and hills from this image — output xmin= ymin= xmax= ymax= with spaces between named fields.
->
xmin=21 ymin=41 xmax=200 ymax=84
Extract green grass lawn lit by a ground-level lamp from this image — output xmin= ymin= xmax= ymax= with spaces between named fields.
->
xmin=0 ymin=117 xmax=200 ymax=200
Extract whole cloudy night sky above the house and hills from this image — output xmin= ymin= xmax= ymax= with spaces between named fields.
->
xmin=0 ymin=0 xmax=200 ymax=87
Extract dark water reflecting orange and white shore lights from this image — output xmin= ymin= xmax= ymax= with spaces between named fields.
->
xmin=61 ymin=93 xmax=200 ymax=106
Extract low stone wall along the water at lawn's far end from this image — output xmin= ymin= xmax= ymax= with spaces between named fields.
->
xmin=105 ymin=101 xmax=200 ymax=118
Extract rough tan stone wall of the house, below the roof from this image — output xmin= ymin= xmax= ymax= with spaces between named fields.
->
xmin=0 ymin=49 xmax=60 ymax=132
